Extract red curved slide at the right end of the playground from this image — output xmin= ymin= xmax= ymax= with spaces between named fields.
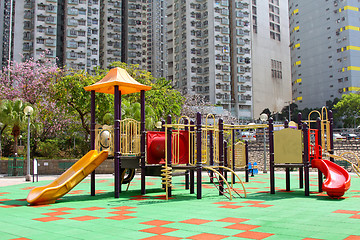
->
xmin=311 ymin=159 xmax=350 ymax=197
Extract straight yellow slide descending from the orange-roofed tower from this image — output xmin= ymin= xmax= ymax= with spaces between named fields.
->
xmin=26 ymin=150 xmax=108 ymax=205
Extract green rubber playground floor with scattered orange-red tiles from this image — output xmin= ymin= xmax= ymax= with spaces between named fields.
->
xmin=0 ymin=172 xmax=360 ymax=240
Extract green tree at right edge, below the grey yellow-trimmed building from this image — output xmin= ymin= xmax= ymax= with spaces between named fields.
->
xmin=334 ymin=93 xmax=360 ymax=127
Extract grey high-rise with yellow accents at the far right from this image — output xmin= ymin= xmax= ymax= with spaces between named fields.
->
xmin=289 ymin=0 xmax=360 ymax=108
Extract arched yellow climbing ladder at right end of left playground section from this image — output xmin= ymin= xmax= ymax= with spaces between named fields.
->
xmin=203 ymin=166 xmax=246 ymax=200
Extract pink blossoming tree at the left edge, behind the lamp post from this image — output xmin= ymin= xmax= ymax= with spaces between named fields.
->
xmin=0 ymin=57 xmax=70 ymax=154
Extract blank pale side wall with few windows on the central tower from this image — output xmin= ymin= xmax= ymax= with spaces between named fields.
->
xmin=251 ymin=0 xmax=291 ymax=118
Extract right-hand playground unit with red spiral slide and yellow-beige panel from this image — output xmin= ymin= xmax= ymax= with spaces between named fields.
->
xmin=269 ymin=108 xmax=359 ymax=197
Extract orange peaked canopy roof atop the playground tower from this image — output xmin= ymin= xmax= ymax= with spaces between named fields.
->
xmin=84 ymin=67 xmax=151 ymax=95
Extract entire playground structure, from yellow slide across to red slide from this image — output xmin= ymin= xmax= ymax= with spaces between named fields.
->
xmin=27 ymin=68 xmax=358 ymax=204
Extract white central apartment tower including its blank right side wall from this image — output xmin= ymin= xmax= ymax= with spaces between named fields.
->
xmin=167 ymin=0 xmax=291 ymax=120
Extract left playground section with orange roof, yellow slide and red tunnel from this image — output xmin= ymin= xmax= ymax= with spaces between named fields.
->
xmin=27 ymin=68 xmax=248 ymax=205
